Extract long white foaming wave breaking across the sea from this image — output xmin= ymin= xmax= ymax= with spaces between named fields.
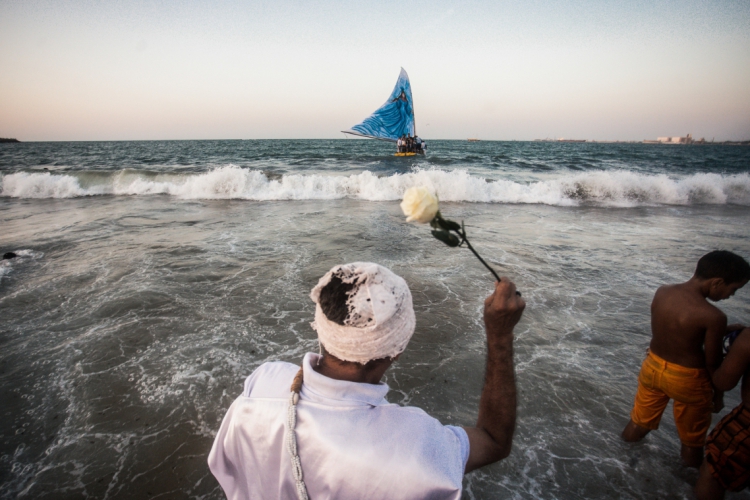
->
xmin=0 ymin=165 xmax=750 ymax=206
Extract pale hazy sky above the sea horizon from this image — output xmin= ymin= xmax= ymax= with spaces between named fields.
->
xmin=0 ymin=0 xmax=750 ymax=141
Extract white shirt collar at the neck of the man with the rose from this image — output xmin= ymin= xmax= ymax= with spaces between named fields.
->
xmin=300 ymin=352 xmax=388 ymax=406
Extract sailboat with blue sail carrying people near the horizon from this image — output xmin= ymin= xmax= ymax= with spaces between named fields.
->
xmin=342 ymin=68 xmax=427 ymax=156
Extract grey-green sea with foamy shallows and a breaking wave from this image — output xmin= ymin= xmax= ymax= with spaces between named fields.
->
xmin=0 ymin=140 xmax=750 ymax=499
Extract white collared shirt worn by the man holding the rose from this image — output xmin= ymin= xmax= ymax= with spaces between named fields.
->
xmin=208 ymin=353 xmax=469 ymax=500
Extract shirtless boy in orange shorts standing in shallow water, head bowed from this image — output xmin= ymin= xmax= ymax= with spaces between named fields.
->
xmin=622 ymin=250 xmax=750 ymax=467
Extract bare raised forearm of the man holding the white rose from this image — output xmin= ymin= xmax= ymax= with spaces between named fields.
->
xmin=477 ymin=329 xmax=516 ymax=457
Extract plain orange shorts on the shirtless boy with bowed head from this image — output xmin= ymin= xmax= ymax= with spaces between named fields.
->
xmin=630 ymin=351 xmax=713 ymax=447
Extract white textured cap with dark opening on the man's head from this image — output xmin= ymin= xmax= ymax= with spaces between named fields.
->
xmin=310 ymin=262 xmax=416 ymax=364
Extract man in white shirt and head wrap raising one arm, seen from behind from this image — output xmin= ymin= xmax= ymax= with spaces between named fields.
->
xmin=208 ymin=262 xmax=526 ymax=500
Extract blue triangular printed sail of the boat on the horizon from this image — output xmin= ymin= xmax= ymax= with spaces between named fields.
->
xmin=347 ymin=68 xmax=414 ymax=141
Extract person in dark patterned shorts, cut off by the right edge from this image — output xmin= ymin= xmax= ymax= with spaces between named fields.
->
xmin=695 ymin=325 xmax=750 ymax=500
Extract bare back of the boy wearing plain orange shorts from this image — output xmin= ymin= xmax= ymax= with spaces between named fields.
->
xmin=650 ymin=283 xmax=726 ymax=368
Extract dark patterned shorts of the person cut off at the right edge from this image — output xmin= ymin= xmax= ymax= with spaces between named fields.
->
xmin=706 ymin=403 xmax=750 ymax=491
